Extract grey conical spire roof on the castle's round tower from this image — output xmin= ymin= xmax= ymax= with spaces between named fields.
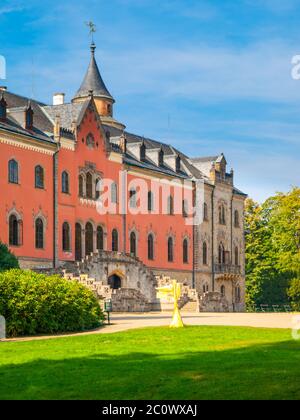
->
xmin=74 ymin=42 xmax=114 ymax=100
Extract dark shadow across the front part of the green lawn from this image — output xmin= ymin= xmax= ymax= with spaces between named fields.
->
xmin=0 ymin=341 xmax=300 ymax=400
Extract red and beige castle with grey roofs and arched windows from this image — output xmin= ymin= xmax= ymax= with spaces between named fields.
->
xmin=0 ymin=43 xmax=246 ymax=311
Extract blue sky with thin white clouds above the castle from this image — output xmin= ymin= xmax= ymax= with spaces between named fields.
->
xmin=0 ymin=0 xmax=300 ymax=201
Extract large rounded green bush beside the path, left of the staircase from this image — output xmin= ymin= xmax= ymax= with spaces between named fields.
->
xmin=0 ymin=270 xmax=104 ymax=337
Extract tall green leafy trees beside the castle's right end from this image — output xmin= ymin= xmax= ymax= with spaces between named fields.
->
xmin=245 ymin=188 xmax=300 ymax=308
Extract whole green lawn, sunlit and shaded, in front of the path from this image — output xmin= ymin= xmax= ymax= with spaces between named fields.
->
xmin=0 ymin=327 xmax=300 ymax=399
